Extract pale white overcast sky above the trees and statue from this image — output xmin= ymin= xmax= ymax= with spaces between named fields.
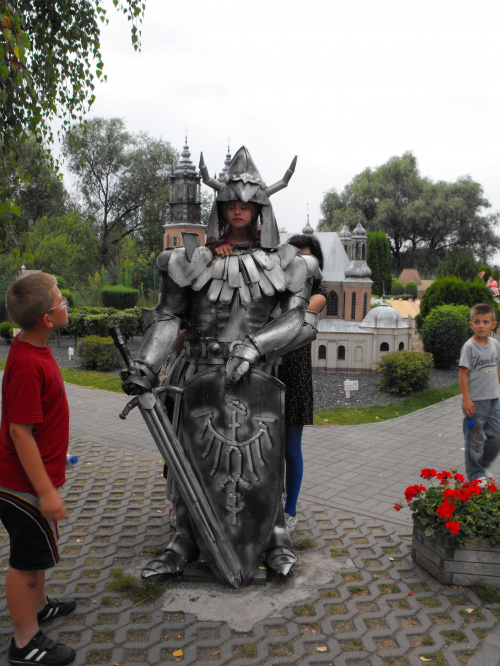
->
xmin=75 ymin=0 xmax=500 ymax=240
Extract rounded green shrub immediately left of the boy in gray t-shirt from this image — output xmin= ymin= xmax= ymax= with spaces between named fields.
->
xmin=420 ymin=305 xmax=471 ymax=368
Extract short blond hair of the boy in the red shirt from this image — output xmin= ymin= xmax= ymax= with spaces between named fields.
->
xmin=7 ymin=273 xmax=57 ymax=331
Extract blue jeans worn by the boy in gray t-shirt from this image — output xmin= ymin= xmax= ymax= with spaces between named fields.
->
xmin=463 ymin=398 xmax=500 ymax=481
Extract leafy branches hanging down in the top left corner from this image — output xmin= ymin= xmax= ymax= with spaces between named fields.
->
xmin=0 ymin=0 xmax=145 ymax=233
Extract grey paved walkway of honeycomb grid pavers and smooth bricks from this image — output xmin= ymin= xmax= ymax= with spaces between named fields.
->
xmin=0 ymin=378 xmax=500 ymax=666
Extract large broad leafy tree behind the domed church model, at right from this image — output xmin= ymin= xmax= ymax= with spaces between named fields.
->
xmin=319 ymin=152 xmax=500 ymax=269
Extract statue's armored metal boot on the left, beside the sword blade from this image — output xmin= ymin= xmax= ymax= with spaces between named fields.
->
xmin=141 ymin=502 xmax=200 ymax=580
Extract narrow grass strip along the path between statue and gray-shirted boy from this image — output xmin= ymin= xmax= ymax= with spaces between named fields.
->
xmin=314 ymin=382 xmax=460 ymax=425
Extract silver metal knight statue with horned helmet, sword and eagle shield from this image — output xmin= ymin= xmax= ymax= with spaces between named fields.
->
xmin=115 ymin=146 xmax=320 ymax=587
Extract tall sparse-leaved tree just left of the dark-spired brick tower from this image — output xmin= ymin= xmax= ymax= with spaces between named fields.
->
xmin=63 ymin=118 xmax=178 ymax=268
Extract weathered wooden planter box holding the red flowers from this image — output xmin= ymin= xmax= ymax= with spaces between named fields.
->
xmin=411 ymin=520 xmax=500 ymax=587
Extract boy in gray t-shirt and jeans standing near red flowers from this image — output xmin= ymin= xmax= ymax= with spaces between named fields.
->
xmin=459 ymin=303 xmax=500 ymax=486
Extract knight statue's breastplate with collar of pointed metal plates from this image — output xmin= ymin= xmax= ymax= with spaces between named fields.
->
xmin=158 ymin=243 xmax=317 ymax=358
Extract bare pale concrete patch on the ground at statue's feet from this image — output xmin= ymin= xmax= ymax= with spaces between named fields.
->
xmin=161 ymin=552 xmax=354 ymax=632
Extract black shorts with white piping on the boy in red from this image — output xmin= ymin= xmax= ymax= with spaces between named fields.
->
xmin=0 ymin=489 xmax=61 ymax=571
